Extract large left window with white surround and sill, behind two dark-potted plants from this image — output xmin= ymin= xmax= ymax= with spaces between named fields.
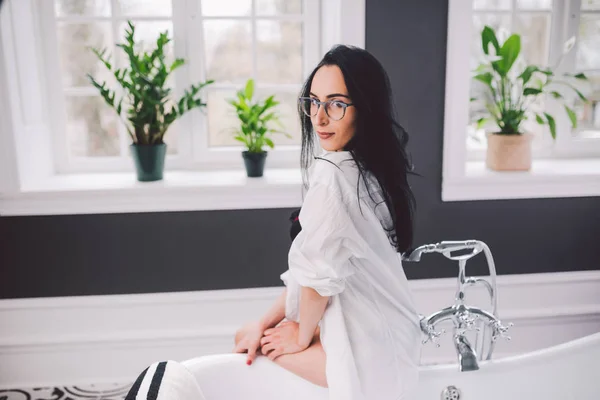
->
xmin=0 ymin=0 xmax=365 ymax=216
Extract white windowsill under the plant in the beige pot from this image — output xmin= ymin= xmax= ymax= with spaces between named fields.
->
xmin=442 ymin=158 xmax=600 ymax=201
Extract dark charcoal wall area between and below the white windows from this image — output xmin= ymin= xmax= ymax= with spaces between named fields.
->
xmin=0 ymin=0 xmax=600 ymax=298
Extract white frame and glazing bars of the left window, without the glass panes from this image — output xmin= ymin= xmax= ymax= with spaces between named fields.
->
xmin=37 ymin=0 xmax=321 ymax=173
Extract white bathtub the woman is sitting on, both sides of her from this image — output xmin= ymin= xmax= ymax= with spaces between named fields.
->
xmin=183 ymin=332 xmax=600 ymax=400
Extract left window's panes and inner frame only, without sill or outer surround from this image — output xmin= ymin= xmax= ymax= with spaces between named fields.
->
xmin=36 ymin=0 xmax=321 ymax=173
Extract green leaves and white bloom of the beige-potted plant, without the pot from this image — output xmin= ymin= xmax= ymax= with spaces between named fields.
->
xmin=471 ymin=26 xmax=587 ymax=139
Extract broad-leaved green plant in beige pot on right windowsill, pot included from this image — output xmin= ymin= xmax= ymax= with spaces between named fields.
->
xmin=471 ymin=26 xmax=587 ymax=171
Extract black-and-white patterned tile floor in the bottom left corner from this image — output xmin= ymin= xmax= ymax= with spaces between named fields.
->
xmin=0 ymin=383 xmax=131 ymax=400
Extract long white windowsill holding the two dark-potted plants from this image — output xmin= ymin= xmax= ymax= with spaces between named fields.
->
xmin=0 ymin=168 xmax=302 ymax=216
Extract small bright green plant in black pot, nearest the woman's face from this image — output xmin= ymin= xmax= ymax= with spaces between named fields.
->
xmin=228 ymin=79 xmax=291 ymax=177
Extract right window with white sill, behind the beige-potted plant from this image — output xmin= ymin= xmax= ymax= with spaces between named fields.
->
xmin=442 ymin=0 xmax=600 ymax=201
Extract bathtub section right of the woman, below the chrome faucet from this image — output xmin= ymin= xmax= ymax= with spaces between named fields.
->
xmin=417 ymin=332 xmax=600 ymax=400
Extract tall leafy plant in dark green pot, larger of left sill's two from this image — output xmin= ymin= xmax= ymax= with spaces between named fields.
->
xmin=88 ymin=21 xmax=213 ymax=182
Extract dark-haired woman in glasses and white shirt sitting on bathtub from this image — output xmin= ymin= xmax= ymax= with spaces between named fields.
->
xmin=190 ymin=46 xmax=421 ymax=400
